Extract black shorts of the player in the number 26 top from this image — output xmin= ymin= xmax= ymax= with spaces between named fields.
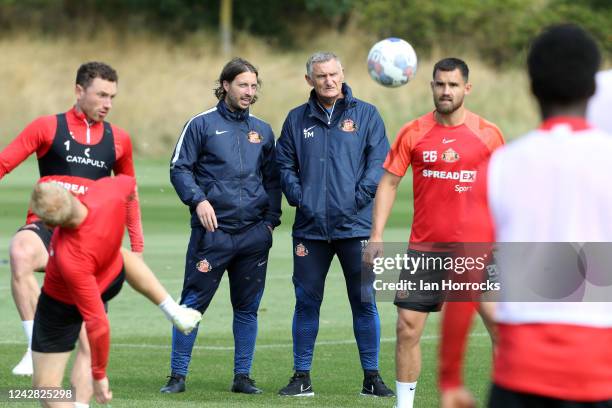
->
xmin=393 ymin=249 xmax=452 ymax=313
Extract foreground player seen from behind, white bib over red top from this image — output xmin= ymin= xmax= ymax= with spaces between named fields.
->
xmin=450 ymin=24 xmax=612 ymax=408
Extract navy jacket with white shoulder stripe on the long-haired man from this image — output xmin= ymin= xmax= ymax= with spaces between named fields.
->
xmin=170 ymin=101 xmax=281 ymax=233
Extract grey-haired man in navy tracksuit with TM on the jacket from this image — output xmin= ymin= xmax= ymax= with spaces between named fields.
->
xmin=276 ymin=52 xmax=393 ymax=396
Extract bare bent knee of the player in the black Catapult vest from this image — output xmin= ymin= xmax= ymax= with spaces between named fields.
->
xmin=9 ymin=231 xmax=48 ymax=279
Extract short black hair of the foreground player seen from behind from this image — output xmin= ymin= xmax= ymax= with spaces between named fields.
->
xmin=527 ymin=24 xmax=601 ymax=105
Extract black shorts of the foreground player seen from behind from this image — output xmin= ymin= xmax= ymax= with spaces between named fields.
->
xmin=488 ymin=384 xmax=612 ymax=408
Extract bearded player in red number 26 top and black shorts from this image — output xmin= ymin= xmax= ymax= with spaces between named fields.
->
xmin=366 ymin=58 xmax=504 ymax=408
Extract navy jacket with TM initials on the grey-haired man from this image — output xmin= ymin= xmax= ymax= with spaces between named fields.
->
xmin=276 ymin=84 xmax=389 ymax=240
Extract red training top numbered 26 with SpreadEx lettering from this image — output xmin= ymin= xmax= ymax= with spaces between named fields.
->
xmin=383 ymin=110 xmax=504 ymax=251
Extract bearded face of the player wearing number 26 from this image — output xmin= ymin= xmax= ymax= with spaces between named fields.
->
xmin=431 ymin=69 xmax=472 ymax=114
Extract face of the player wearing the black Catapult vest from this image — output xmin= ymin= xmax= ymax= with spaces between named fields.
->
xmin=75 ymin=78 xmax=117 ymax=122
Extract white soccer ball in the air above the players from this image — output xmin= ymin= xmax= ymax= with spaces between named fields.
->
xmin=368 ymin=38 xmax=417 ymax=88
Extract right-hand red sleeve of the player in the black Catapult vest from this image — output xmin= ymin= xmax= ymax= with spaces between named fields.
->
xmin=113 ymin=126 xmax=144 ymax=252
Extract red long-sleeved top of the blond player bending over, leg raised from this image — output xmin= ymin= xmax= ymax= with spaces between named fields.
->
xmin=43 ymin=175 xmax=136 ymax=380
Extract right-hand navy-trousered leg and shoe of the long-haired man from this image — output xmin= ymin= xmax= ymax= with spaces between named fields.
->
xmin=227 ymin=222 xmax=272 ymax=394
